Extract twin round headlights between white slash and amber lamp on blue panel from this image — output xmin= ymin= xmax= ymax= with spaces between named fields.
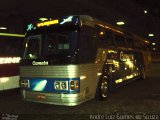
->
xmin=54 ymin=81 xmax=68 ymax=90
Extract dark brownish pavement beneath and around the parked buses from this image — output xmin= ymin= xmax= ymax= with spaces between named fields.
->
xmin=0 ymin=63 xmax=160 ymax=120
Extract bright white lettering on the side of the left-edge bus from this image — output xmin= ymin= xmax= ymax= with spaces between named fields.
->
xmin=0 ymin=57 xmax=21 ymax=64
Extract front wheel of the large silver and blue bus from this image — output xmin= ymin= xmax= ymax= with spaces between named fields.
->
xmin=96 ymin=76 xmax=109 ymax=100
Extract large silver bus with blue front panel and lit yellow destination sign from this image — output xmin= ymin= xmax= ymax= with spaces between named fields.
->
xmin=20 ymin=15 xmax=150 ymax=106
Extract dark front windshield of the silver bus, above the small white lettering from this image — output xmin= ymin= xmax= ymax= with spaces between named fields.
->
xmin=24 ymin=31 xmax=78 ymax=64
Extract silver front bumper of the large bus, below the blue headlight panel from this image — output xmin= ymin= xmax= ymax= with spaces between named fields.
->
xmin=21 ymin=90 xmax=85 ymax=106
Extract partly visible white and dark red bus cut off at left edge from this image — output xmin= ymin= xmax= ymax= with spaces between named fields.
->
xmin=0 ymin=33 xmax=24 ymax=91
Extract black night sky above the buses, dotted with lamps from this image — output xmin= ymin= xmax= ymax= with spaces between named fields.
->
xmin=0 ymin=0 xmax=160 ymax=42
